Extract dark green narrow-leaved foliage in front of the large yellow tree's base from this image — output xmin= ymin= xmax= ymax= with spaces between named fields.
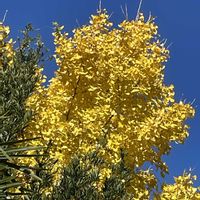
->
xmin=52 ymin=152 xmax=131 ymax=200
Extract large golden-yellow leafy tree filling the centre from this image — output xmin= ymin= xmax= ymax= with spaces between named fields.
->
xmin=21 ymin=10 xmax=198 ymax=199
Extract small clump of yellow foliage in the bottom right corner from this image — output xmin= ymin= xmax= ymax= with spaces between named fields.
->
xmin=159 ymin=172 xmax=200 ymax=200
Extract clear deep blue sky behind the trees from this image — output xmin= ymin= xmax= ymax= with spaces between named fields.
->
xmin=0 ymin=0 xmax=200 ymax=184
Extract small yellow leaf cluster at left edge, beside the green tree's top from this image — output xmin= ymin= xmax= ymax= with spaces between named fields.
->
xmin=0 ymin=22 xmax=14 ymax=68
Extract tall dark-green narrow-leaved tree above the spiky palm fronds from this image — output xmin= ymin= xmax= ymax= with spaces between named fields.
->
xmin=0 ymin=25 xmax=44 ymax=142
